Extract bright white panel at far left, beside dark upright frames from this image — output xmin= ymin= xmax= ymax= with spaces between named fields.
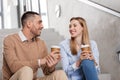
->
xmin=3 ymin=0 xmax=18 ymax=29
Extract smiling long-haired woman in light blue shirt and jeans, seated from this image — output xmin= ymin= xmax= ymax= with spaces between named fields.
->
xmin=60 ymin=17 xmax=99 ymax=80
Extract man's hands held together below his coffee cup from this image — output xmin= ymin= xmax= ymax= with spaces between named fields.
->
xmin=46 ymin=51 xmax=61 ymax=68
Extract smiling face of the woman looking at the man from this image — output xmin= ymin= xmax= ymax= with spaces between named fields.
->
xmin=69 ymin=20 xmax=83 ymax=38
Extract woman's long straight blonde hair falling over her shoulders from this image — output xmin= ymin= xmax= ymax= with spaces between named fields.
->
xmin=70 ymin=17 xmax=90 ymax=55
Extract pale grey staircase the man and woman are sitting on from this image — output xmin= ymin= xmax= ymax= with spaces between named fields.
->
xmin=0 ymin=29 xmax=111 ymax=80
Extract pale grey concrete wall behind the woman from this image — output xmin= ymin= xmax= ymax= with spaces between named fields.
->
xmin=47 ymin=0 xmax=120 ymax=80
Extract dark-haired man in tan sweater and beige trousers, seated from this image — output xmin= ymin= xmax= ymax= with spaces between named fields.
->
xmin=2 ymin=11 xmax=67 ymax=80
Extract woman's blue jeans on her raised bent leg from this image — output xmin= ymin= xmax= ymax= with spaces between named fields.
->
xmin=80 ymin=59 xmax=99 ymax=80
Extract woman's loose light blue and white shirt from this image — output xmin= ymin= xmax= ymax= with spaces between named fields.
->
xmin=60 ymin=39 xmax=100 ymax=80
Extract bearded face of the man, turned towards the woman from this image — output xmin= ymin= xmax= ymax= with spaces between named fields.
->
xmin=30 ymin=15 xmax=43 ymax=37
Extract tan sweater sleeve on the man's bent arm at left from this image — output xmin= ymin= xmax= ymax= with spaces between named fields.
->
xmin=3 ymin=37 xmax=38 ymax=73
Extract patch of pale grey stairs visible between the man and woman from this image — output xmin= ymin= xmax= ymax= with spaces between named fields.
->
xmin=40 ymin=29 xmax=64 ymax=52
